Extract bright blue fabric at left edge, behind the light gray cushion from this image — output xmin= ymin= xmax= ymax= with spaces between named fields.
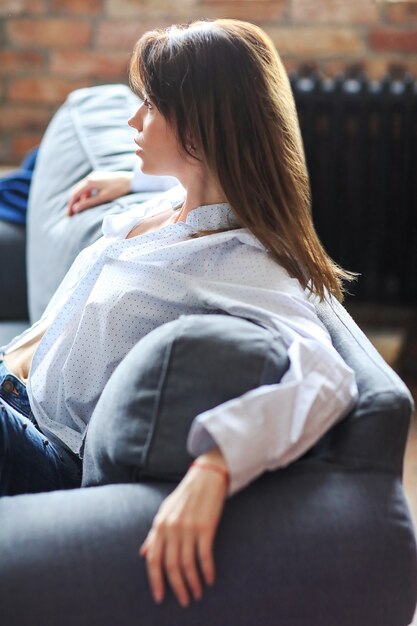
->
xmin=0 ymin=148 xmax=38 ymax=224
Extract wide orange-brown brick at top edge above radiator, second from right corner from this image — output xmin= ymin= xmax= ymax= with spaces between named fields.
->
xmin=291 ymin=0 xmax=379 ymax=24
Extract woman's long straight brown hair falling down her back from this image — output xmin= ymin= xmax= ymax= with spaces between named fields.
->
xmin=130 ymin=19 xmax=353 ymax=299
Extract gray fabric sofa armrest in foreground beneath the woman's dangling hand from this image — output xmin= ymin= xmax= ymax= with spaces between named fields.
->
xmin=0 ymin=470 xmax=417 ymax=626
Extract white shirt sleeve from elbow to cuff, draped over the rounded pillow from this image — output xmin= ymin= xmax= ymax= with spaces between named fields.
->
xmin=188 ymin=337 xmax=358 ymax=494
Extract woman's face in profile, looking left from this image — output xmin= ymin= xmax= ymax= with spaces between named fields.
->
xmin=128 ymin=98 xmax=186 ymax=178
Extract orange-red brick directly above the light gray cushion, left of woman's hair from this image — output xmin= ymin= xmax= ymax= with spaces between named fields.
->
xmin=51 ymin=50 xmax=130 ymax=78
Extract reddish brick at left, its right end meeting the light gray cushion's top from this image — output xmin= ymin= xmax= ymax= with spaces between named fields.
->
xmin=7 ymin=76 xmax=90 ymax=104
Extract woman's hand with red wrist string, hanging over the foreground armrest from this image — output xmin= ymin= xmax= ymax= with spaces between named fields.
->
xmin=139 ymin=448 xmax=228 ymax=607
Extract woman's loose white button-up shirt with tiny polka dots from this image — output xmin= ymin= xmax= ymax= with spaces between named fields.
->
xmin=1 ymin=186 xmax=357 ymax=493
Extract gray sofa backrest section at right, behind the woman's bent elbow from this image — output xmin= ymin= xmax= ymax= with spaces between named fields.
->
xmin=306 ymin=301 xmax=413 ymax=474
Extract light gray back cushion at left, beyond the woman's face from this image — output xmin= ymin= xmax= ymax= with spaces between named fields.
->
xmin=27 ymin=85 xmax=151 ymax=321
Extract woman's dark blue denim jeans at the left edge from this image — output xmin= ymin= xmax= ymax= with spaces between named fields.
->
xmin=0 ymin=356 xmax=81 ymax=496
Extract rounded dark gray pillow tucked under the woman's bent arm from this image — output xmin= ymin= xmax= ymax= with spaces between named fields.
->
xmin=83 ymin=314 xmax=289 ymax=486
